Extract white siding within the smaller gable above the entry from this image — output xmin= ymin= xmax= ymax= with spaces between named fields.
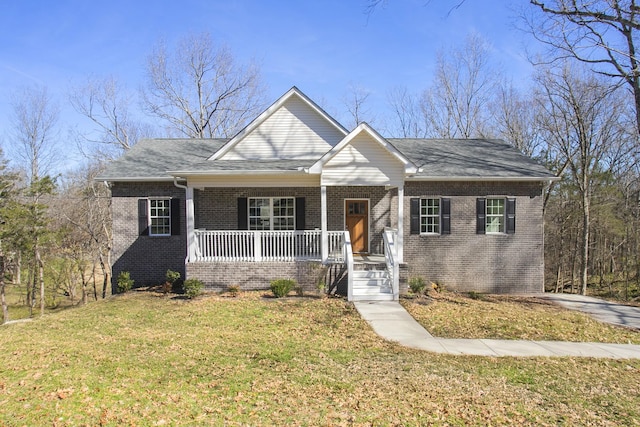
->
xmin=320 ymin=133 xmax=404 ymax=185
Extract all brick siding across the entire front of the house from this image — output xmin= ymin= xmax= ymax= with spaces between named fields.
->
xmin=111 ymin=182 xmax=544 ymax=293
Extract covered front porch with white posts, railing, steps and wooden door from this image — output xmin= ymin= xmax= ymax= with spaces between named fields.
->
xmin=179 ymin=185 xmax=403 ymax=300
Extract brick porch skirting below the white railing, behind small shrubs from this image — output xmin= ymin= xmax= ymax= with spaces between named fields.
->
xmin=186 ymin=260 xmax=326 ymax=292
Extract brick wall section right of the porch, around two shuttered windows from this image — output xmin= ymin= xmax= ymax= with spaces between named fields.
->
xmin=404 ymin=182 xmax=544 ymax=293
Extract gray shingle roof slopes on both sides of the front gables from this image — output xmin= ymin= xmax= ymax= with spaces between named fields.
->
xmin=97 ymin=138 xmax=554 ymax=181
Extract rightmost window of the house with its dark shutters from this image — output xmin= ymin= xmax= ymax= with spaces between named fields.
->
xmin=476 ymin=197 xmax=516 ymax=234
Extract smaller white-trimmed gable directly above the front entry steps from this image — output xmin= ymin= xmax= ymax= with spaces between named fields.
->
xmin=310 ymin=123 xmax=415 ymax=186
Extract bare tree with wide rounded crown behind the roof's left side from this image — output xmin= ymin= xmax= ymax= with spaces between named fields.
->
xmin=142 ymin=33 xmax=264 ymax=138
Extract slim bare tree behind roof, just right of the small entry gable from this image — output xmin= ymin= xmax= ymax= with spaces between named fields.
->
xmin=387 ymin=86 xmax=427 ymax=138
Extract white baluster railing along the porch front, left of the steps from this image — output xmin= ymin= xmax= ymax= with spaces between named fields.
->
xmin=194 ymin=230 xmax=345 ymax=262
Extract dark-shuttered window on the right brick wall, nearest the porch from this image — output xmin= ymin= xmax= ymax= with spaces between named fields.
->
xmin=410 ymin=197 xmax=451 ymax=234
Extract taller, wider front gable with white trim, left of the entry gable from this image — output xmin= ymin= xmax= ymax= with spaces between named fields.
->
xmin=210 ymin=87 xmax=347 ymax=160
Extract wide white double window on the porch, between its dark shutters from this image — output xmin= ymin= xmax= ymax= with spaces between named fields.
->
xmin=249 ymin=197 xmax=296 ymax=230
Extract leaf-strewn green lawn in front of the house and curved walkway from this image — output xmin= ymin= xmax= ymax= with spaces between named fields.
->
xmin=0 ymin=292 xmax=640 ymax=426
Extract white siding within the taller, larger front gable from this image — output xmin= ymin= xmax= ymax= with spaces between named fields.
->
xmin=222 ymin=96 xmax=344 ymax=160
